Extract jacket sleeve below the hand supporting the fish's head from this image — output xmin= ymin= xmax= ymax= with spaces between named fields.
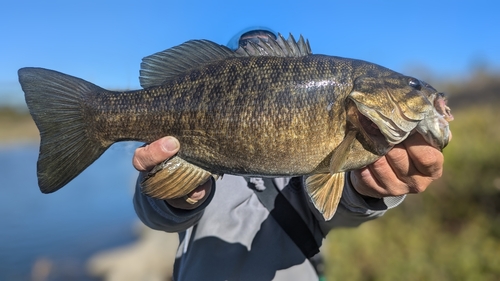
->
xmin=320 ymin=172 xmax=405 ymax=231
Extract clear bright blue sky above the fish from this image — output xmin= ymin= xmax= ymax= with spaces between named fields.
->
xmin=0 ymin=0 xmax=500 ymax=105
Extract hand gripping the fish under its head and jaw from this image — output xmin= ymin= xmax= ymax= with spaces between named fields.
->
xmin=350 ymin=134 xmax=444 ymax=198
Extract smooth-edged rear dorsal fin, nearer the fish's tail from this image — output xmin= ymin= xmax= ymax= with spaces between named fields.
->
xmin=139 ymin=40 xmax=237 ymax=88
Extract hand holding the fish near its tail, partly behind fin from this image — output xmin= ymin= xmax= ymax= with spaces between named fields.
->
xmin=132 ymin=137 xmax=212 ymax=210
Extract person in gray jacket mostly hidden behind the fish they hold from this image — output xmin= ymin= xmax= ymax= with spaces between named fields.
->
xmin=133 ymin=29 xmax=451 ymax=280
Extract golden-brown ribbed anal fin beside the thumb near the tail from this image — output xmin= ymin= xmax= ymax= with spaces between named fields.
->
xmin=141 ymin=156 xmax=212 ymax=200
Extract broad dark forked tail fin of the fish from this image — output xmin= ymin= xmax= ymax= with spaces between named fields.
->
xmin=18 ymin=68 xmax=110 ymax=193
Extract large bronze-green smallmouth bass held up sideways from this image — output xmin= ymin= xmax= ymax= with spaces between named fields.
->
xmin=18 ymin=34 xmax=453 ymax=220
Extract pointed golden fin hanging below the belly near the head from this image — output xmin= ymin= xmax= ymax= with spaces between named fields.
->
xmin=306 ymin=172 xmax=345 ymax=221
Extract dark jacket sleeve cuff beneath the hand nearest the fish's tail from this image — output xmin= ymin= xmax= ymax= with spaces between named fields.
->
xmin=134 ymin=177 xmax=215 ymax=232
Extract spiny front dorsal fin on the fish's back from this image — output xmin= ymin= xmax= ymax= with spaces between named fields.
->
xmin=235 ymin=34 xmax=312 ymax=57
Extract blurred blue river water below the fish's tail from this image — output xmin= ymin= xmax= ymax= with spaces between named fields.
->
xmin=0 ymin=143 xmax=143 ymax=280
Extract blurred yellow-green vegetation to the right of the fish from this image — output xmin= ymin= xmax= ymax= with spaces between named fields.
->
xmin=323 ymin=69 xmax=500 ymax=281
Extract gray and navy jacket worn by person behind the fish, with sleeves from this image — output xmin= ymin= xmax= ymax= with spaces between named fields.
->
xmin=134 ymin=175 xmax=404 ymax=281
